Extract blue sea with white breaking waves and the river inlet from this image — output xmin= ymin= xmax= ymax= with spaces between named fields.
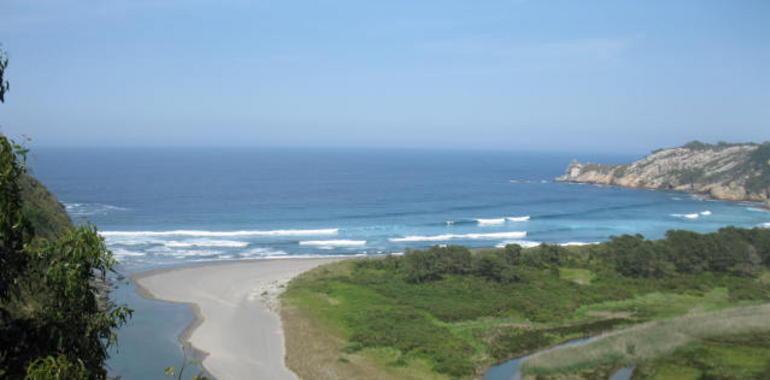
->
xmin=29 ymin=147 xmax=770 ymax=380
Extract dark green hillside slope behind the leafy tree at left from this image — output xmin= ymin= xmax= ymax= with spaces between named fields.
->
xmin=19 ymin=174 xmax=72 ymax=240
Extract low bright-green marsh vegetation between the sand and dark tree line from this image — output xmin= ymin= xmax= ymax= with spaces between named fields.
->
xmin=282 ymin=261 xmax=750 ymax=379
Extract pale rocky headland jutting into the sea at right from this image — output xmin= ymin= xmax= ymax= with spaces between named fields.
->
xmin=556 ymin=142 xmax=770 ymax=206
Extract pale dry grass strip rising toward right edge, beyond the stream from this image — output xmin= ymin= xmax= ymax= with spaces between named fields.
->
xmin=523 ymin=304 xmax=770 ymax=377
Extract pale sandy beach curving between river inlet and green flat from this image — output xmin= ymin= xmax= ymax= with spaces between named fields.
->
xmin=134 ymin=259 xmax=339 ymax=380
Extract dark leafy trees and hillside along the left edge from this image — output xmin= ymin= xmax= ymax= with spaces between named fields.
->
xmin=0 ymin=52 xmax=131 ymax=380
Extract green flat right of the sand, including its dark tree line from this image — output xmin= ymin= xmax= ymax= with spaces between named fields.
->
xmin=283 ymin=228 xmax=770 ymax=378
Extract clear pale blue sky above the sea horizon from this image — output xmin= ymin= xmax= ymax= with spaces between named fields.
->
xmin=0 ymin=0 xmax=770 ymax=152
